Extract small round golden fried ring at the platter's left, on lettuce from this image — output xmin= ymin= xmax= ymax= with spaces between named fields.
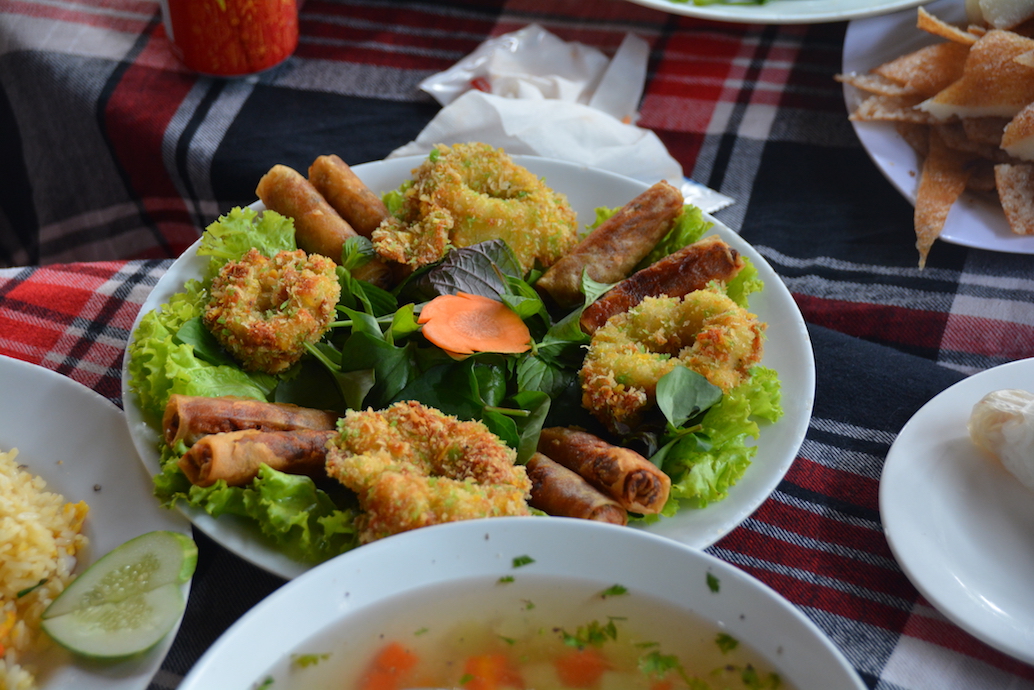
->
xmin=203 ymin=248 xmax=341 ymax=373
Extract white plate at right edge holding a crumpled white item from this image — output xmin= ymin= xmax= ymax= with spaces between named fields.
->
xmin=880 ymin=359 xmax=1034 ymax=663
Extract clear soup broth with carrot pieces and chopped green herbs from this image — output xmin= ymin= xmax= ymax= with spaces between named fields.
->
xmin=254 ymin=574 xmax=791 ymax=690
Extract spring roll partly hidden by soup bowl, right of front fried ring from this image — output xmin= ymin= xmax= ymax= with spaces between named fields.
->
xmin=525 ymin=453 xmax=629 ymax=524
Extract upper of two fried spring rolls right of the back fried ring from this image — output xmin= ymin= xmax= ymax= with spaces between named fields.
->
xmin=536 ymin=182 xmax=685 ymax=308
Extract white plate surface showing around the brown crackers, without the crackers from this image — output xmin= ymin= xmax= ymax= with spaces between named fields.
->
xmin=842 ymin=0 xmax=1034 ymax=253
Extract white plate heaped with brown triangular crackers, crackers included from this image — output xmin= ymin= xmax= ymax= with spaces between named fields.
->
xmin=838 ymin=0 xmax=1034 ymax=268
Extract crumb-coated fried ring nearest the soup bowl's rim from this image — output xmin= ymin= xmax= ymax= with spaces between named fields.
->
xmin=327 ymin=400 xmax=531 ymax=543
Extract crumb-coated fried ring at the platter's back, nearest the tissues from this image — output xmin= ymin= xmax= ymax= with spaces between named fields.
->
xmin=373 ymin=144 xmax=578 ymax=271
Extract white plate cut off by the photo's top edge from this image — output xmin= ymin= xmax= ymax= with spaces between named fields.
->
xmin=629 ymin=0 xmax=926 ymax=24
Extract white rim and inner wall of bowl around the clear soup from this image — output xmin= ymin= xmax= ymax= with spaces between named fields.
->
xmin=180 ymin=517 xmax=864 ymax=690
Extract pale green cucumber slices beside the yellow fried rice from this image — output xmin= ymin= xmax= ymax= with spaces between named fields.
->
xmin=41 ymin=532 xmax=197 ymax=658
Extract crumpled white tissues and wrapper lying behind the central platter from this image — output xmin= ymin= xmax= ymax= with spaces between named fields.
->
xmin=389 ymin=24 xmax=733 ymax=213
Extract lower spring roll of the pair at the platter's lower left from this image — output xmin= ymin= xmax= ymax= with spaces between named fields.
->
xmin=179 ymin=429 xmax=337 ymax=486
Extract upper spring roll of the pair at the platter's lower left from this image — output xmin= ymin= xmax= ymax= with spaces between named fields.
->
xmin=161 ymin=394 xmax=340 ymax=446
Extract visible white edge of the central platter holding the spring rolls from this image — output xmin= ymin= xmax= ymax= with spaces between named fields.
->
xmin=122 ymin=155 xmax=815 ymax=578
